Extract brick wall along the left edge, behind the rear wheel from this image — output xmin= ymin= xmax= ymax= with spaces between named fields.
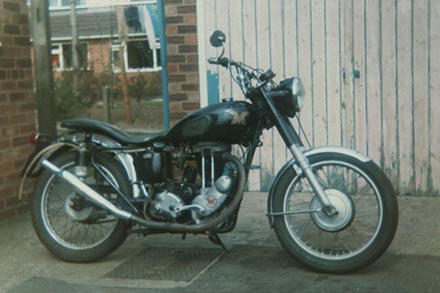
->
xmin=0 ymin=0 xmax=35 ymax=217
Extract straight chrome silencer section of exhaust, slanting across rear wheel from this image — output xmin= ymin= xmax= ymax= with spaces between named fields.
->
xmin=41 ymin=160 xmax=134 ymax=220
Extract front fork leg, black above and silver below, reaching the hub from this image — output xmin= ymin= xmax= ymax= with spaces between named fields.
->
xmin=262 ymin=90 xmax=338 ymax=217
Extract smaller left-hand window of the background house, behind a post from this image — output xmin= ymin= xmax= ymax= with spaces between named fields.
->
xmin=52 ymin=44 xmax=87 ymax=70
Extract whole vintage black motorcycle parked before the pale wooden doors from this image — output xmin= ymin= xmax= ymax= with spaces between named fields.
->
xmin=20 ymin=31 xmax=398 ymax=273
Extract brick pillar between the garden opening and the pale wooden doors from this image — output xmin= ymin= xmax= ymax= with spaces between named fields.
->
xmin=165 ymin=0 xmax=200 ymax=125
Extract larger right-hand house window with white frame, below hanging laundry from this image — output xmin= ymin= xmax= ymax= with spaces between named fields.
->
xmin=112 ymin=39 xmax=161 ymax=72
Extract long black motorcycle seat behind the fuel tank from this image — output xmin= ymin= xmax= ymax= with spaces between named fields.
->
xmin=61 ymin=119 xmax=165 ymax=145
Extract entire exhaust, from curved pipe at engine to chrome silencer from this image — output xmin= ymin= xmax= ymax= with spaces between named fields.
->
xmin=41 ymin=153 xmax=246 ymax=233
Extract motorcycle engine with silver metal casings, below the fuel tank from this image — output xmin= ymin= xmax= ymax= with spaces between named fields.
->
xmin=140 ymin=144 xmax=237 ymax=223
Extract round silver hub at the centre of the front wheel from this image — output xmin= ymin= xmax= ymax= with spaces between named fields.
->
xmin=310 ymin=189 xmax=355 ymax=232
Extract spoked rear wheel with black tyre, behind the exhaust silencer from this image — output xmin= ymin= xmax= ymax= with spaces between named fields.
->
xmin=32 ymin=153 xmax=130 ymax=262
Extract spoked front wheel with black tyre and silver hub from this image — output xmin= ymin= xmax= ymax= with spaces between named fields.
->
xmin=273 ymin=153 xmax=398 ymax=273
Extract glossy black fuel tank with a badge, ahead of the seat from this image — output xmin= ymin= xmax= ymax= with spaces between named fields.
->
xmin=165 ymin=101 xmax=257 ymax=144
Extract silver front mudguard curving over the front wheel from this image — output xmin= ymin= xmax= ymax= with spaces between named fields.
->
xmin=267 ymin=146 xmax=371 ymax=227
